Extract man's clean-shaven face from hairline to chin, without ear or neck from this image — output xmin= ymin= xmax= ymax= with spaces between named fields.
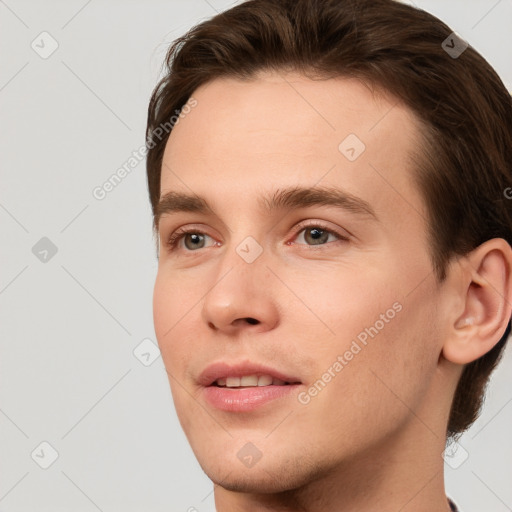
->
xmin=153 ymin=73 xmax=448 ymax=492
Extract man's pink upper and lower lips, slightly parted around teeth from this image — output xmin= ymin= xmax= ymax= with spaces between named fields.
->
xmin=198 ymin=362 xmax=301 ymax=412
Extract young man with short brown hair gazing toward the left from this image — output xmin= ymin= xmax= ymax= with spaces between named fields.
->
xmin=147 ymin=0 xmax=512 ymax=512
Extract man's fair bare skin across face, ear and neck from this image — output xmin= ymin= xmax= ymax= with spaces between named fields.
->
xmin=153 ymin=72 xmax=512 ymax=512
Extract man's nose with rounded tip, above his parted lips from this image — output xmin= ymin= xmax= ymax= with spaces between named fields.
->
xmin=202 ymin=253 xmax=279 ymax=335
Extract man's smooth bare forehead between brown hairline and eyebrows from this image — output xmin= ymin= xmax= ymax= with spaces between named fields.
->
xmin=161 ymin=73 xmax=425 ymax=228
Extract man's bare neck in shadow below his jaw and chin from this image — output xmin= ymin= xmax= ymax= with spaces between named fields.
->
xmin=215 ymin=415 xmax=450 ymax=512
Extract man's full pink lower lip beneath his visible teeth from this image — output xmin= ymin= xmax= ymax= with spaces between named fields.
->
xmin=203 ymin=384 xmax=300 ymax=412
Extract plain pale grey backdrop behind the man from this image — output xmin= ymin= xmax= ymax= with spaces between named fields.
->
xmin=0 ymin=0 xmax=512 ymax=512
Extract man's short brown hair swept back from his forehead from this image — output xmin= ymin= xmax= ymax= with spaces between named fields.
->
xmin=146 ymin=0 xmax=512 ymax=437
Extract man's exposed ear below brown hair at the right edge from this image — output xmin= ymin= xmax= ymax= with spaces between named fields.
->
xmin=443 ymin=238 xmax=512 ymax=364
